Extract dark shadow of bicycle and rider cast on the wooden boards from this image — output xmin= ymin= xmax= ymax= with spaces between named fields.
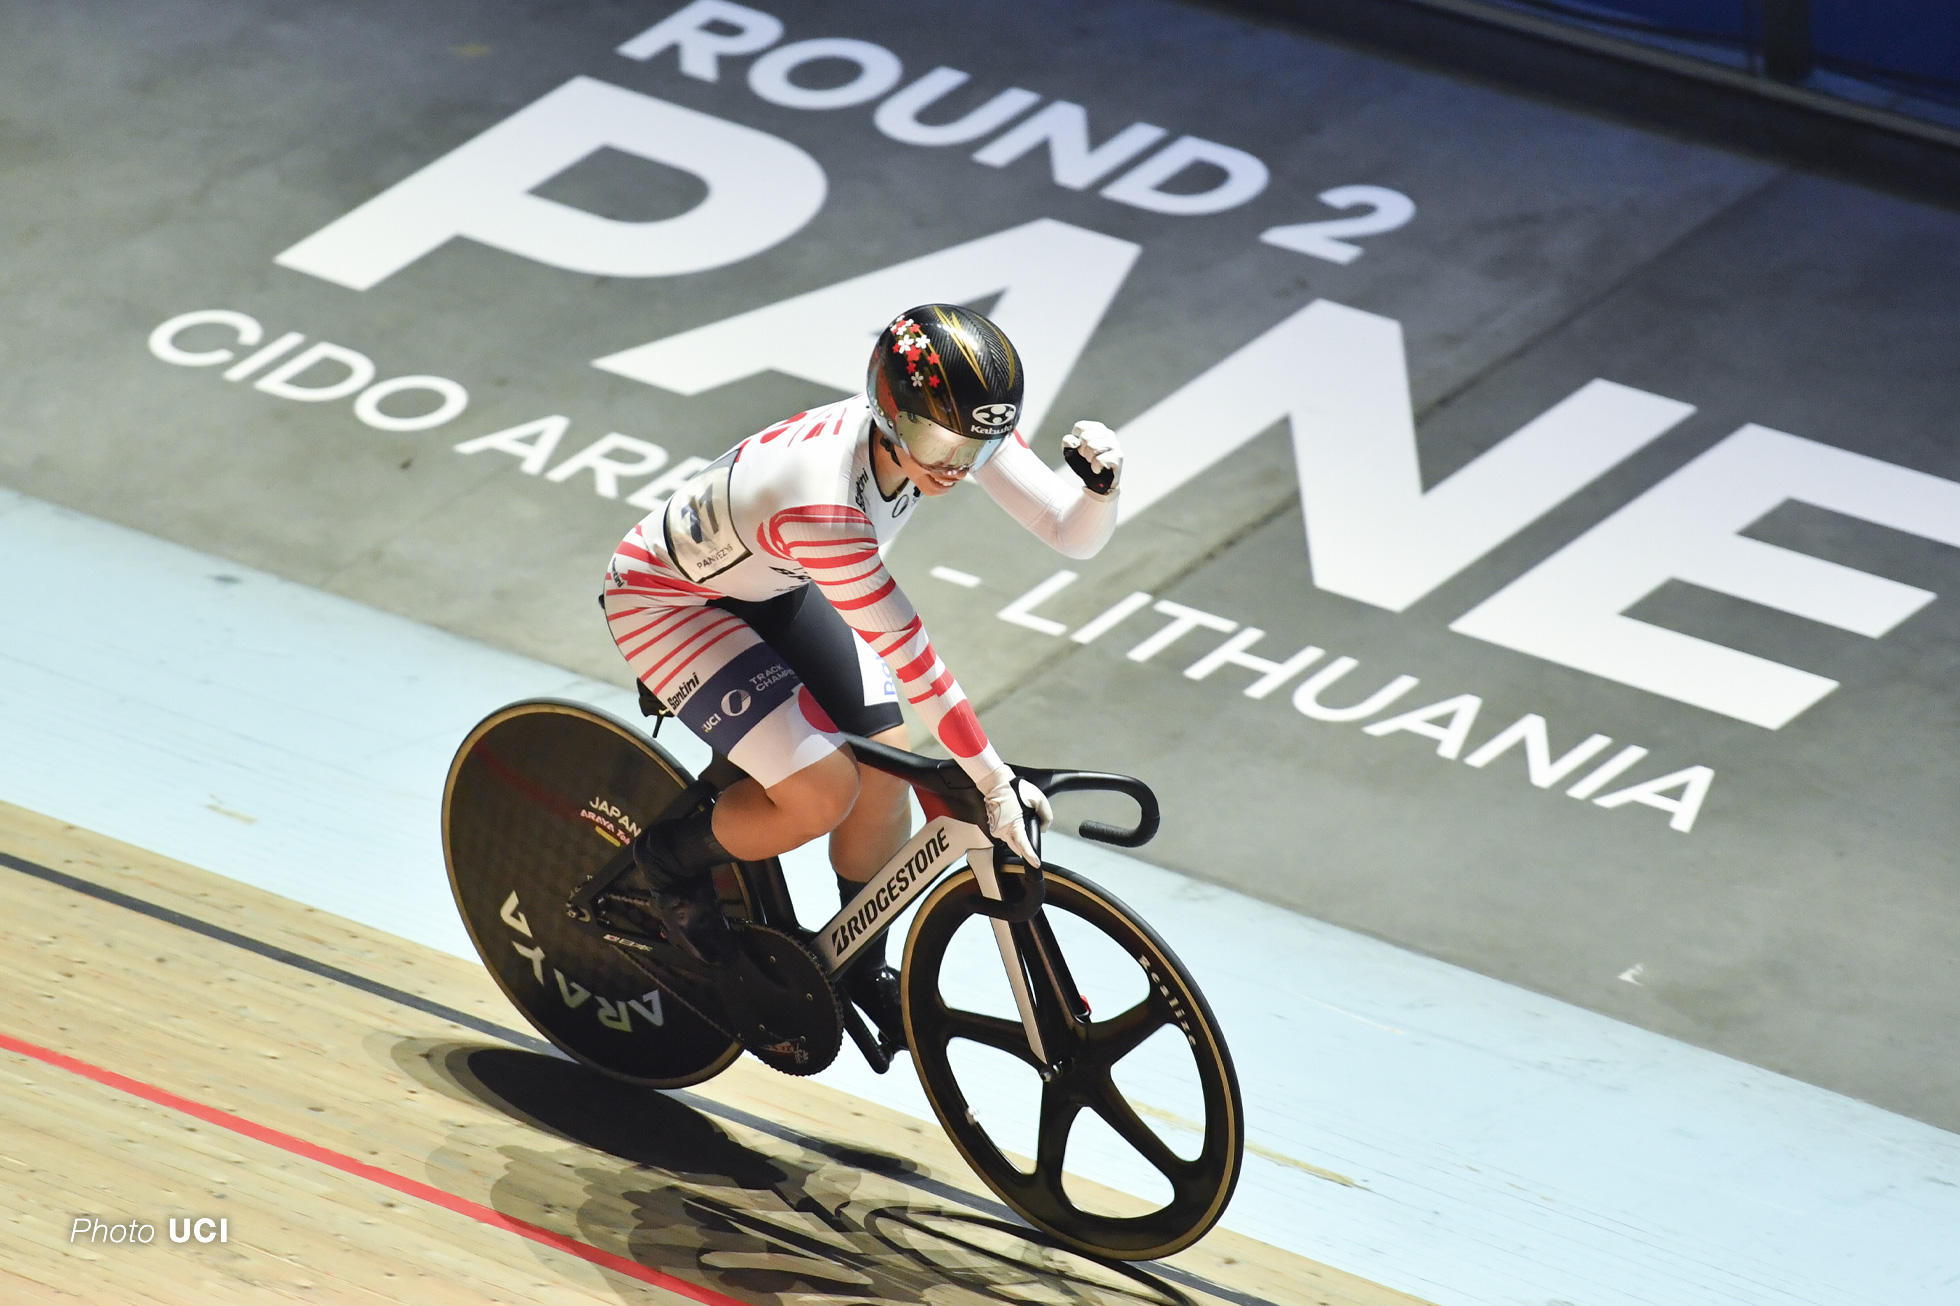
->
xmin=388 ymin=1039 xmax=1194 ymax=1306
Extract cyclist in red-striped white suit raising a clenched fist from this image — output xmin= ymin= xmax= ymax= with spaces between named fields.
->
xmin=602 ymin=304 xmax=1123 ymax=1043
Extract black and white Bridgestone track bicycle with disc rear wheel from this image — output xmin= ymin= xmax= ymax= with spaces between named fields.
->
xmin=443 ymin=698 xmax=1245 ymax=1259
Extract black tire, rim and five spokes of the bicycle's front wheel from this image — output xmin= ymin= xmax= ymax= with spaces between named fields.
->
xmin=902 ymin=865 xmax=1245 ymax=1261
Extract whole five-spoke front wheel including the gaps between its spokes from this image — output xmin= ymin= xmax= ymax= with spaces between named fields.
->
xmin=904 ymin=865 xmax=1245 ymax=1259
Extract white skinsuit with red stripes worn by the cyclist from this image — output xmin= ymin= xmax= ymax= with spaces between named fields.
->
xmin=604 ymin=396 xmax=1115 ymax=792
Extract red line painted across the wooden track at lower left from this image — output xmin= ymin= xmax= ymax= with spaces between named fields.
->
xmin=0 ymin=1031 xmax=747 ymax=1306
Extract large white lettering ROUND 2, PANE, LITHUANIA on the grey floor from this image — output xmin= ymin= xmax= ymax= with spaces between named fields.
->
xmin=151 ymin=0 xmax=1960 ymax=829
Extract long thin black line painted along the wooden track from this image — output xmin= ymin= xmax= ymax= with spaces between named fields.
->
xmin=0 ymin=853 xmax=1274 ymax=1306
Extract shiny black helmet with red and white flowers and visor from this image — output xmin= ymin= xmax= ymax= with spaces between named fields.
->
xmin=864 ymin=304 xmax=1021 ymax=473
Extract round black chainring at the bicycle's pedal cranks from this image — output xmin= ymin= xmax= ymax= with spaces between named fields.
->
xmin=715 ymin=920 xmax=845 ymax=1075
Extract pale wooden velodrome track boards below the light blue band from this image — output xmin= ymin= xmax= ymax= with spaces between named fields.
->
xmin=0 ymin=804 xmax=1415 ymax=1306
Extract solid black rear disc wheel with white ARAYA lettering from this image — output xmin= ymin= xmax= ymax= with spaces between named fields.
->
xmin=443 ymin=698 xmax=755 ymax=1088
